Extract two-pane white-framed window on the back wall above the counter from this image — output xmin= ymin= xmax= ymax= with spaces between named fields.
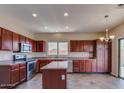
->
xmin=48 ymin=42 xmax=68 ymax=56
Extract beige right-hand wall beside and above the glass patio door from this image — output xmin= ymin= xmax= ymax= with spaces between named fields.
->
xmin=110 ymin=23 xmax=124 ymax=76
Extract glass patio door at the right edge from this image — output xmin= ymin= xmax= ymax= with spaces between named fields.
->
xmin=119 ymin=39 xmax=124 ymax=78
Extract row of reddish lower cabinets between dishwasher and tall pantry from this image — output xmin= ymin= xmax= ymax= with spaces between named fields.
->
xmin=73 ymin=59 xmax=96 ymax=72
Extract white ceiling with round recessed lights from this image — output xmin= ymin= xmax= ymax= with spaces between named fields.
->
xmin=0 ymin=4 xmax=124 ymax=33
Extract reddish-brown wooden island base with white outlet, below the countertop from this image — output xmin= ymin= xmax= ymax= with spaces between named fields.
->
xmin=42 ymin=69 xmax=67 ymax=89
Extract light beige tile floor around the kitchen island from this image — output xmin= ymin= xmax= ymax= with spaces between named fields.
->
xmin=15 ymin=74 xmax=124 ymax=89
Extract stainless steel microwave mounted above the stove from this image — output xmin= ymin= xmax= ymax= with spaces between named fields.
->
xmin=20 ymin=43 xmax=32 ymax=52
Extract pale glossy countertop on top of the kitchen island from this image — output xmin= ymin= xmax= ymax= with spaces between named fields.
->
xmin=41 ymin=61 xmax=68 ymax=70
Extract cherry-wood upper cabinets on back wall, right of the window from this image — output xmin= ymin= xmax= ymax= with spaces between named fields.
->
xmin=70 ymin=40 xmax=95 ymax=52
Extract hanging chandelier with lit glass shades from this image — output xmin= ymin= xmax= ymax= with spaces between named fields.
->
xmin=100 ymin=15 xmax=115 ymax=42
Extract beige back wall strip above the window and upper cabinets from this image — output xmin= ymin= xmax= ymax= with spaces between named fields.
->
xmin=35 ymin=32 xmax=104 ymax=41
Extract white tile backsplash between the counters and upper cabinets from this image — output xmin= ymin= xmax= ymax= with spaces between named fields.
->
xmin=0 ymin=51 xmax=93 ymax=61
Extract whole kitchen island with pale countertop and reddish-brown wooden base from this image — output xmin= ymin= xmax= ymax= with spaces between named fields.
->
xmin=41 ymin=61 xmax=68 ymax=89
